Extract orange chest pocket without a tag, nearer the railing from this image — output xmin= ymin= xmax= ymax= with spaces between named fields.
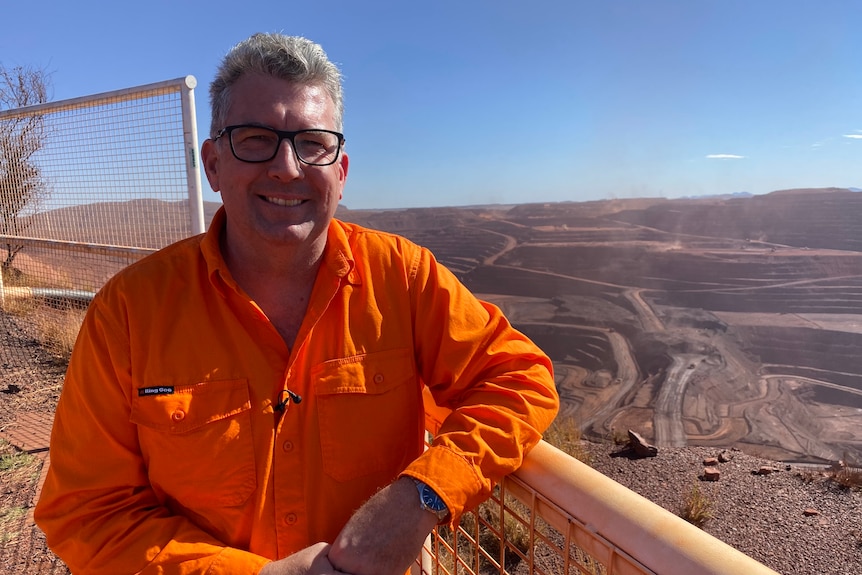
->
xmin=312 ymin=349 xmax=424 ymax=484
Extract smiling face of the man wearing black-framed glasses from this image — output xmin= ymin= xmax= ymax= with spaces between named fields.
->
xmin=201 ymin=74 xmax=348 ymax=255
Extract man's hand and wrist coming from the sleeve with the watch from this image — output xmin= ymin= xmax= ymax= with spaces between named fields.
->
xmin=329 ymin=477 xmax=437 ymax=575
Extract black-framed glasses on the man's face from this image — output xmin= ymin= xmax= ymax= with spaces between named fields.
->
xmin=213 ymin=124 xmax=344 ymax=166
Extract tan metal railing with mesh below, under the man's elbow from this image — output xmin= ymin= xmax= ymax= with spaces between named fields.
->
xmin=414 ymin=395 xmax=777 ymax=575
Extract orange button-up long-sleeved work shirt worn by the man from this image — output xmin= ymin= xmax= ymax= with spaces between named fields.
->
xmin=35 ymin=211 xmax=559 ymax=575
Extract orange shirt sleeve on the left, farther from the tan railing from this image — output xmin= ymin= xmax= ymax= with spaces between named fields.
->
xmin=35 ymin=294 xmax=269 ymax=575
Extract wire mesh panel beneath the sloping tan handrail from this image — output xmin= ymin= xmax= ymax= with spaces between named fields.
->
xmin=411 ymin=404 xmax=664 ymax=575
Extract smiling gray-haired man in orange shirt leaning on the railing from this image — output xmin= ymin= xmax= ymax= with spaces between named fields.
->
xmin=36 ymin=34 xmax=558 ymax=575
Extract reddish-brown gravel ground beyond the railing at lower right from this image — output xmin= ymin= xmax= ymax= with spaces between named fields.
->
xmin=584 ymin=443 xmax=862 ymax=575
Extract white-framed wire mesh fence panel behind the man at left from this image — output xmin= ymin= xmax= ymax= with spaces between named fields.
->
xmin=0 ymin=76 xmax=204 ymax=385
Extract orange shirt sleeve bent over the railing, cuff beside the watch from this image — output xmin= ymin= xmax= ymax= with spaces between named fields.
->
xmin=404 ymin=245 xmax=559 ymax=521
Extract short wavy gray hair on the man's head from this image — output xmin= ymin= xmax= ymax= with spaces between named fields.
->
xmin=210 ymin=33 xmax=344 ymax=138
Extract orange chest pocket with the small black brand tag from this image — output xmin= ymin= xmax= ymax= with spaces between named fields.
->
xmin=130 ymin=380 xmax=257 ymax=508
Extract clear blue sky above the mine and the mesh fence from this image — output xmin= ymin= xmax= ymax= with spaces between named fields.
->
xmin=0 ymin=0 xmax=862 ymax=209
